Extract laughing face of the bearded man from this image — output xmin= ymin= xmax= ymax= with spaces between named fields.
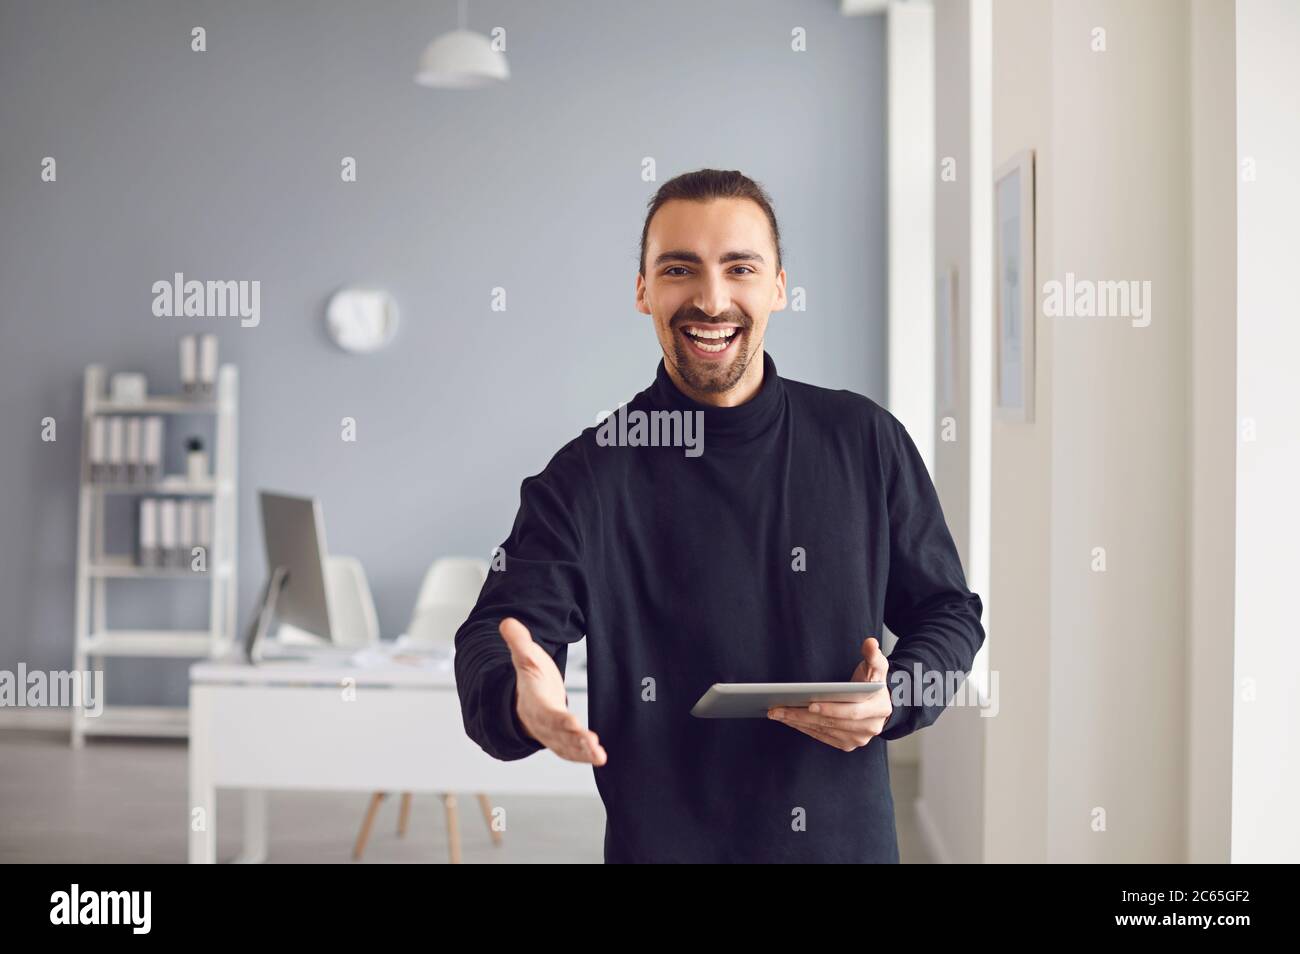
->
xmin=637 ymin=199 xmax=785 ymax=403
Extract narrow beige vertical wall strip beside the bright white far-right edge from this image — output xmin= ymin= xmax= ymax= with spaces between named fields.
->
xmin=1186 ymin=0 xmax=1236 ymax=863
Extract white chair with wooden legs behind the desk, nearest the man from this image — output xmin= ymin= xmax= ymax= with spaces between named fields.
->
xmin=352 ymin=556 xmax=501 ymax=864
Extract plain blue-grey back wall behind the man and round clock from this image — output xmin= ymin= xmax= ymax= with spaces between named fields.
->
xmin=0 ymin=0 xmax=885 ymax=702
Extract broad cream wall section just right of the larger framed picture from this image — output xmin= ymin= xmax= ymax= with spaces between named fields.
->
xmin=1039 ymin=0 xmax=1191 ymax=862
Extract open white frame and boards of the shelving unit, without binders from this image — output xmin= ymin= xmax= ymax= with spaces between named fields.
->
xmin=72 ymin=364 xmax=239 ymax=747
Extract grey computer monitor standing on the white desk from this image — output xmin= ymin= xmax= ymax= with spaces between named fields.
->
xmin=244 ymin=490 xmax=334 ymax=663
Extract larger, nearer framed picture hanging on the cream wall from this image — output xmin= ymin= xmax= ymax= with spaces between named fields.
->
xmin=993 ymin=149 xmax=1037 ymax=422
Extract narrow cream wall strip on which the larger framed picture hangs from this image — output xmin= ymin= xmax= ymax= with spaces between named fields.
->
xmin=983 ymin=0 xmax=1056 ymax=862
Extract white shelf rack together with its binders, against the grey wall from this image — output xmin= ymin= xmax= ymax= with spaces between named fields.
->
xmin=72 ymin=361 xmax=238 ymax=747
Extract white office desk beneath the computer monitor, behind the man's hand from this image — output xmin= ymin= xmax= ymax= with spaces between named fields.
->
xmin=190 ymin=650 xmax=598 ymax=863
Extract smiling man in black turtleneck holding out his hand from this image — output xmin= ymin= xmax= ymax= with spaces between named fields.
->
xmin=455 ymin=169 xmax=984 ymax=862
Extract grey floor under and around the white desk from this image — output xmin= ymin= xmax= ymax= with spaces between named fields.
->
xmin=0 ymin=729 xmax=930 ymax=864
